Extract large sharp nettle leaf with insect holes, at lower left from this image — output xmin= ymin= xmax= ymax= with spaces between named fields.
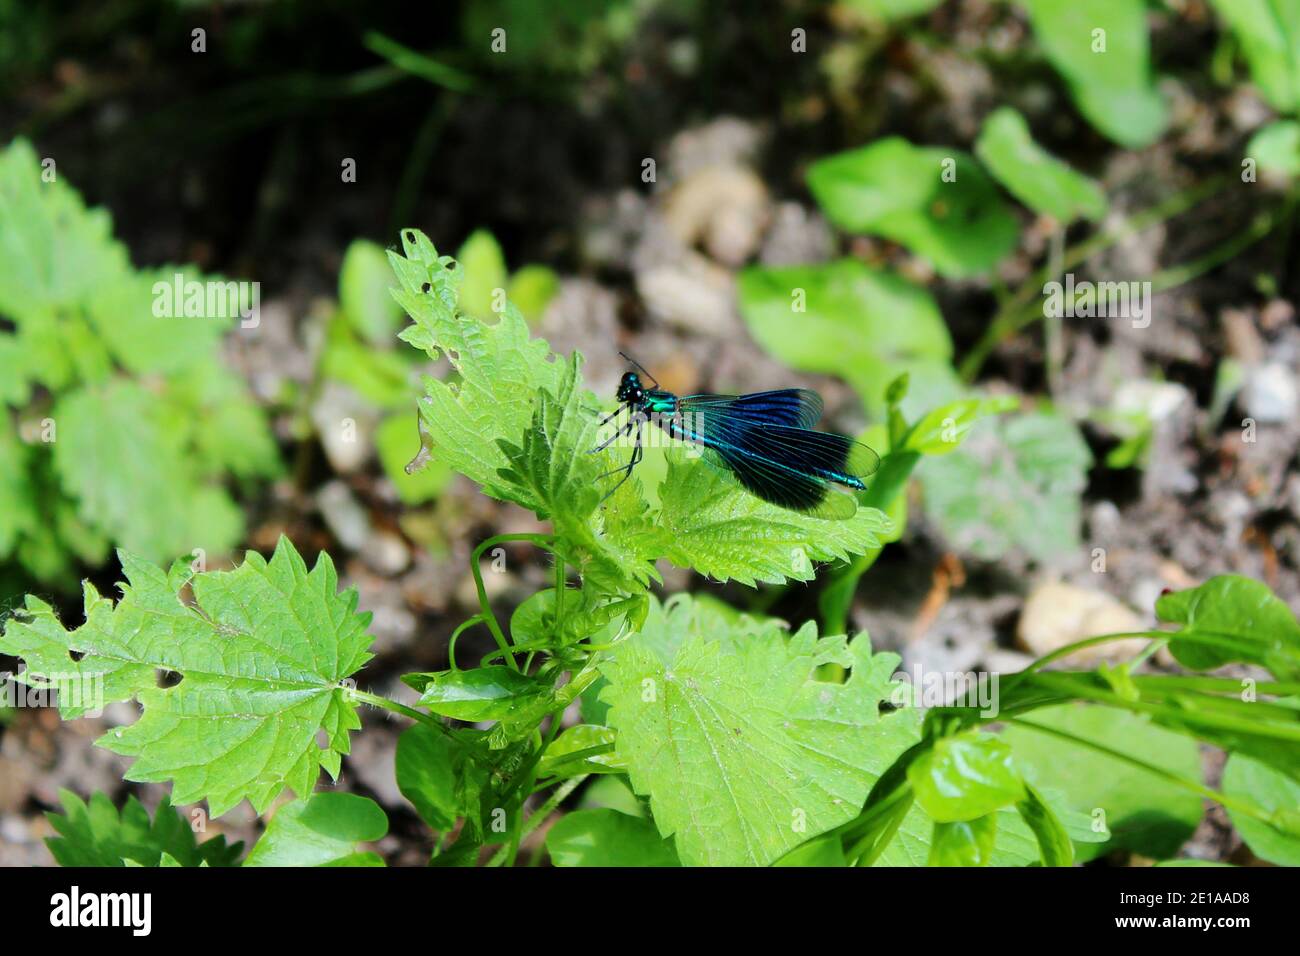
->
xmin=0 ymin=537 xmax=371 ymax=817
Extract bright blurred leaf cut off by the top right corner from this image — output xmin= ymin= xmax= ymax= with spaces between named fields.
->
xmin=1210 ymin=0 xmax=1300 ymax=113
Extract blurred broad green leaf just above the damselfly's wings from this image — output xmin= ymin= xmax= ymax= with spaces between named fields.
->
xmin=738 ymin=259 xmax=959 ymax=415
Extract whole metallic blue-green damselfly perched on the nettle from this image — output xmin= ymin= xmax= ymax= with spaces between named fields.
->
xmin=592 ymin=352 xmax=880 ymax=519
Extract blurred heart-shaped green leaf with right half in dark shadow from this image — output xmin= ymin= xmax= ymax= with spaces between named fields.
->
xmin=807 ymin=137 xmax=1019 ymax=278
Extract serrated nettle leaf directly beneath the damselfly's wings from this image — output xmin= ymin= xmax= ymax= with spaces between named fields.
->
xmin=655 ymin=458 xmax=892 ymax=587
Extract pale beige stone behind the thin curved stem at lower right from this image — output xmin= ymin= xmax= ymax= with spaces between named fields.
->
xmin=1015 ymin=581 xmax=1147 ymax=666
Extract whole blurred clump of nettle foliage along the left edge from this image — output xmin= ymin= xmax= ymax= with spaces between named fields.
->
xmin=0 ymin=139 xmax=280 ymax=585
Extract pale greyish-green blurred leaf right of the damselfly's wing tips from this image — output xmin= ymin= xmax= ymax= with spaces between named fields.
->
xmin=918 ymin=412 xmax=1092 ymax=561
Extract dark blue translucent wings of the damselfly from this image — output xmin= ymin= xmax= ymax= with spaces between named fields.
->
xmin=677 ymin=389 xmax=880 ymax=519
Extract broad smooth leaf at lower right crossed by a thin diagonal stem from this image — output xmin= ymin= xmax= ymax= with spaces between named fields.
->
xmin=1001 ymin=705 xmax=1203 ymax=860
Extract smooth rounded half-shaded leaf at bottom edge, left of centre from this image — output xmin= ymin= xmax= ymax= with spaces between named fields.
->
xmin=244 ymin=793 xmax=389 ymax=866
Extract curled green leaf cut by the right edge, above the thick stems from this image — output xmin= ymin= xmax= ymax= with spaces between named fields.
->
xmin=1156 ymin=575 xmax=1300 ymax=680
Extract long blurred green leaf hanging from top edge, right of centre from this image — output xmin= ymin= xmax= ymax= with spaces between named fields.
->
xmin=1018 ymin=0 xmax=1169 ymax=150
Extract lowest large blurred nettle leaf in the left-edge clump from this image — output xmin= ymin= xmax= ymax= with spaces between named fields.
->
xmin=52 ymin=380 xmax=243 ymax=572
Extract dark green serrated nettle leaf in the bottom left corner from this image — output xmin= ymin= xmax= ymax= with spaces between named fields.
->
xmin=46 ymin=790 xmax=243 ymax=866
